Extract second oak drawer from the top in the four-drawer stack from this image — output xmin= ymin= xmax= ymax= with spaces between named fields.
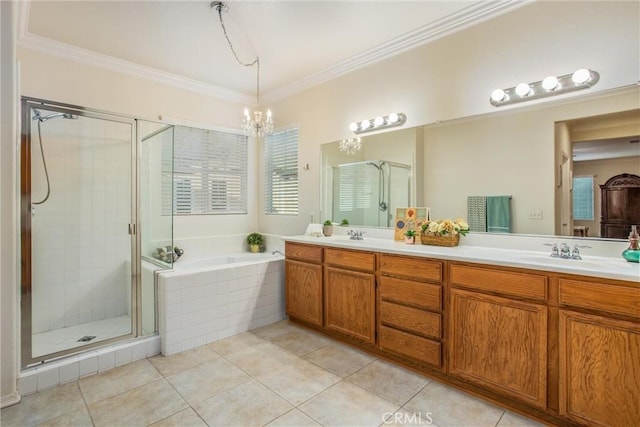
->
xmin=380 ymin=276 xmax=442 ymax=310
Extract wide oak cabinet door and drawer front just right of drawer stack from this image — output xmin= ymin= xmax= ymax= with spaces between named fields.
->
xmin=448 ymin=263 xmax=547 ymax=409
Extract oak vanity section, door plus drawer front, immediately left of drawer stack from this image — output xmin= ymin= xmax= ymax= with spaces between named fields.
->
xmin=324 ymin=248 xmax=376 ymax=346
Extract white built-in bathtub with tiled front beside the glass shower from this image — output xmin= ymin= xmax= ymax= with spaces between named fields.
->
xmin=158 ymin=252 xmax=285 ymax=356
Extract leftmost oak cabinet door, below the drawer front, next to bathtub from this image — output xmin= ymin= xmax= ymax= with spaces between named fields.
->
xmin=285 ymin=260 xmax=322 ymax=326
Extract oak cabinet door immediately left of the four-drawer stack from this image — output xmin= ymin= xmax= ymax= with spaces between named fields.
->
xmin=324 ymin=267 xmax=375 ymax=345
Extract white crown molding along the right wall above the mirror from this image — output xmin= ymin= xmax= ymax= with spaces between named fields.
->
xmin=262 ymin=0 xmax=536 ymax=102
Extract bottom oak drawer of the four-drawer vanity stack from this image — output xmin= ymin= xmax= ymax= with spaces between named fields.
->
xmin=378 ymin=326 xmax=442 ymax=367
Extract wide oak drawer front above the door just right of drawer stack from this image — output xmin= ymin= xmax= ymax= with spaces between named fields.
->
xmin=450 ymin=263 xmax=547 ymax=301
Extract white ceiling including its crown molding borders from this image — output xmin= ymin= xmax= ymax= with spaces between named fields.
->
xmin=18 ymin=0 xmax=530 ymax=102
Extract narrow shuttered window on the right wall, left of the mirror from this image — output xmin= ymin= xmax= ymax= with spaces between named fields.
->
xmin=264 ymin=129 xmax=298 ymax=215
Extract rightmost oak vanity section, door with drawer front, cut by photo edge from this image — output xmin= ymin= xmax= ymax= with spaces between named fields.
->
xmin=558 ymin=278 xmax=640 ymax=426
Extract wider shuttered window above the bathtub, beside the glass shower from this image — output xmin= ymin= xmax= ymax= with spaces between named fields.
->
xmin=163 ymin=126 xmax=247 ymax=215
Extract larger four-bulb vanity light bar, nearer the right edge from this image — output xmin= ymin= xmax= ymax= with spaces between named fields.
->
xmin=489 ymin=68 xmax=600 ymax=107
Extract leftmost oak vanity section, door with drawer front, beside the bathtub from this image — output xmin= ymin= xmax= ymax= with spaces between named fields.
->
xmin=285 ymin=242 xmax=323 ymax=326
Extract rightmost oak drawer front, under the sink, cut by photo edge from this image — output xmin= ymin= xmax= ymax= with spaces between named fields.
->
xmin=558 ymin=279 xmax=640 ymax=317
